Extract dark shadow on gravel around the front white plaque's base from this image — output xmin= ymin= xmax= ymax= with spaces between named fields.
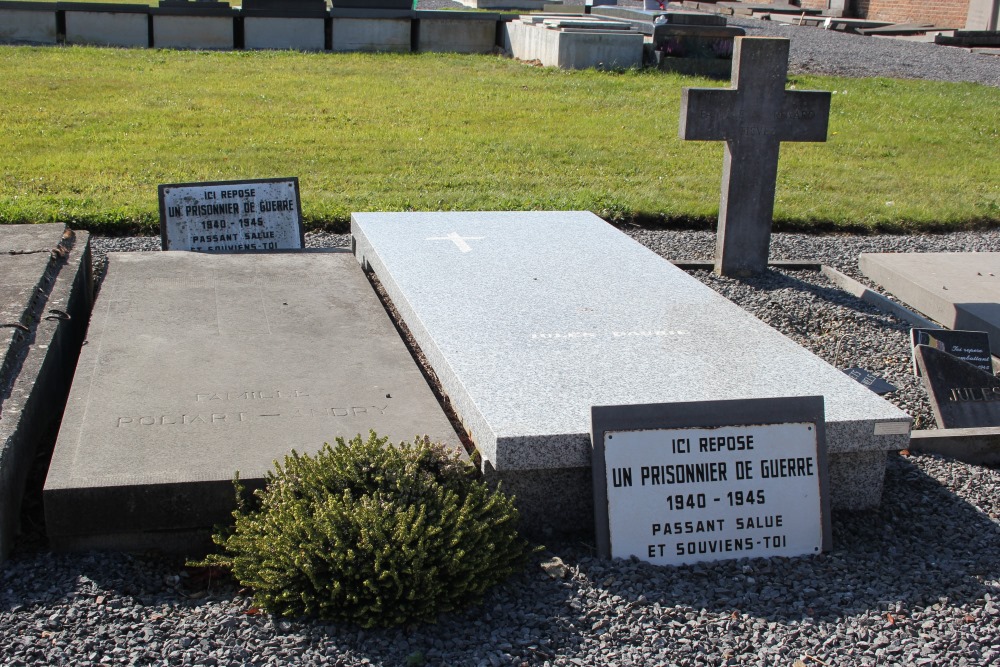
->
xmin=556 ymin=457 xmax=1000 ymax=622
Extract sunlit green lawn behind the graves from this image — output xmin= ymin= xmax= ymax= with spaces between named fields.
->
xmin=0 ymin=47 xmax=1000 ymax=232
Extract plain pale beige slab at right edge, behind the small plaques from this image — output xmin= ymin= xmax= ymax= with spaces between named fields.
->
xmin=858 ymin=252 xmax=1000 ymax=355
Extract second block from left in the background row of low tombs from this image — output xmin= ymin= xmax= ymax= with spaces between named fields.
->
xmin=59 ymin=2 xmax=149 ymax=48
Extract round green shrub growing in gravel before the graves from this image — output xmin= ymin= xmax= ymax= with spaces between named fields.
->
xmin=199 ymin=432 xmax=530 ymax=627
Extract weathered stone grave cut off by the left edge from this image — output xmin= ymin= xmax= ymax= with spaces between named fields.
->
xmin=0 ymin=224 xmax=92 ymax=562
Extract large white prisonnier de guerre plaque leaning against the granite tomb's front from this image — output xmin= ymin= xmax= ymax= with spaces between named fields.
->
xmin=591 ymin=396 xmax=832 ymax=565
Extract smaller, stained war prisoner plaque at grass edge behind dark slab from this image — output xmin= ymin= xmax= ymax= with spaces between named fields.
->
xmin=159 ymin=178 xmax=305 ymax=253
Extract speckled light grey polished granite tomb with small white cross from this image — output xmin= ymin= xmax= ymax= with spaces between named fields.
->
xmin=352 ymin=212 xmax=910 ymax=530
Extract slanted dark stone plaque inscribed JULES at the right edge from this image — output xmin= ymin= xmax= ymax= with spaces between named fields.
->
xmin=914 ymin=345 xmax=1000 ymax=428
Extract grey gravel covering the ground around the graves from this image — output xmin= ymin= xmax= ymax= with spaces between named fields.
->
xmin=0 ymin=7 xmax=1000 ymax=667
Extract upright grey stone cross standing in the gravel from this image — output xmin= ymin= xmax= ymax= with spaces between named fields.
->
xmin=679 ymin=37 xmax=830 ymax=276
